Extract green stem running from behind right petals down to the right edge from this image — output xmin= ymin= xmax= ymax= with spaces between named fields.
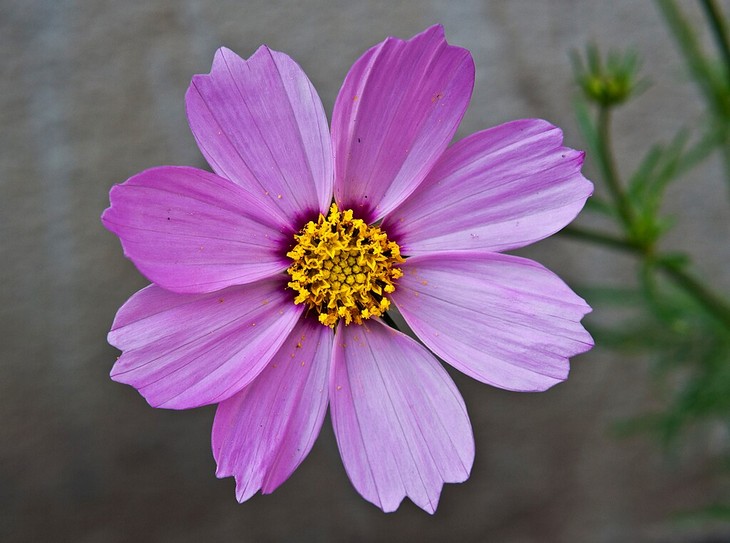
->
xmin=562 ymin=226 xmax=730 ymax=329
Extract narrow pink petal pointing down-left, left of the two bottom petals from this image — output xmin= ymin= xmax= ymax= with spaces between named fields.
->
xmin=212 ymin=319 xmax=333 ymax=502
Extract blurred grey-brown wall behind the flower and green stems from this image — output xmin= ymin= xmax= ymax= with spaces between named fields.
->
xmin=0 ymin=0 xmax=730 ymax=543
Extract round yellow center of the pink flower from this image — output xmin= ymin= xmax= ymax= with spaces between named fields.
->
xmin=286 ymin=204 xmax=405 ymax=327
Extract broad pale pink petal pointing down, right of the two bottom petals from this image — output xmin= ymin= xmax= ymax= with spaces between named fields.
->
xmin=330 ymin=321 xmax=474 ymax=513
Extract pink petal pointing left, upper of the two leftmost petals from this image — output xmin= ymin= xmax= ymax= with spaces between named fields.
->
xmin=102 ymin=166 xmax=291 ymax=293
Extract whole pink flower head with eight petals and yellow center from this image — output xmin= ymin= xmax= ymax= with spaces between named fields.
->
xmin=102 ymin=26 xmax=592 ymax=513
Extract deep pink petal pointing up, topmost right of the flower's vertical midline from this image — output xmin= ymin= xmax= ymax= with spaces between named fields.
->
xmin=332 ymin=26 xmax=474 ymax=222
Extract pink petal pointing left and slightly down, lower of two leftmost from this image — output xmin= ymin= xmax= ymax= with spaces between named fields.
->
xmin=108 ymin=279 xmax=303 ymax=409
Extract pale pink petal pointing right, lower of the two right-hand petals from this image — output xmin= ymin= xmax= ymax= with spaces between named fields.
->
xmin=392 ymin=252 xmax=593 ymax=391
